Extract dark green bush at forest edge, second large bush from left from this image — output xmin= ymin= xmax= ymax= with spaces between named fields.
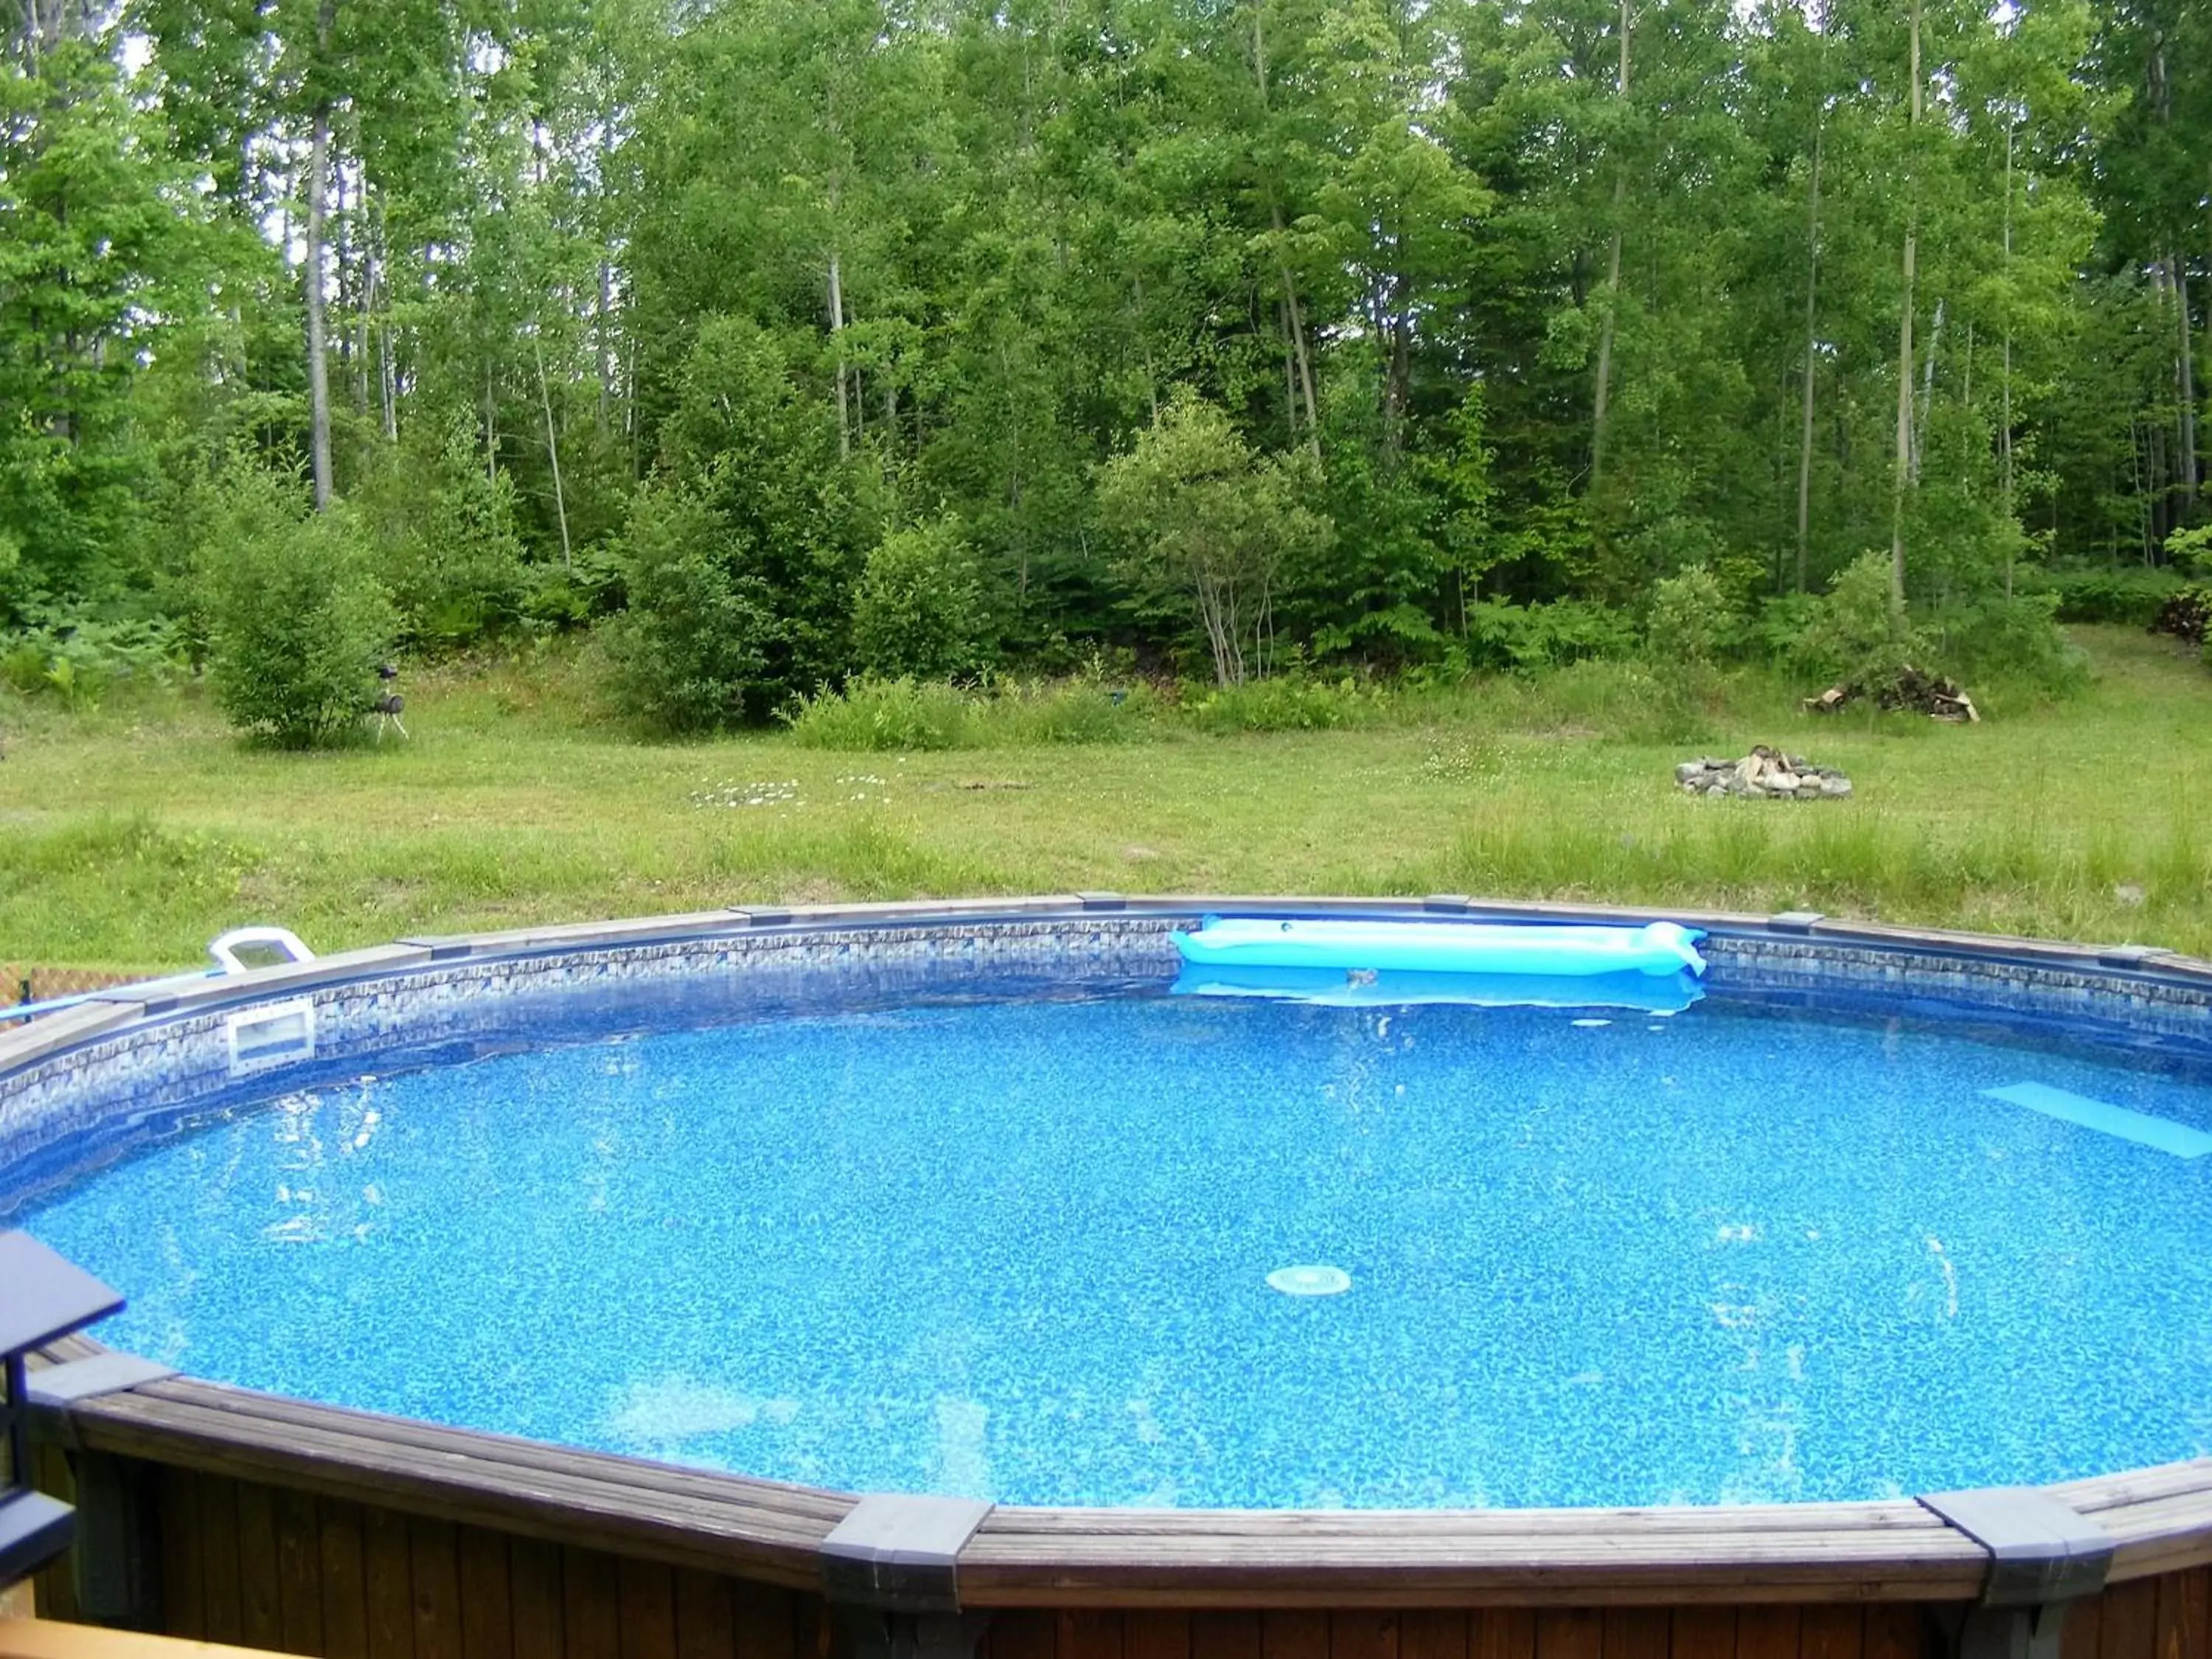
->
xmin=604 ymin=484 xmax=776 ymax=732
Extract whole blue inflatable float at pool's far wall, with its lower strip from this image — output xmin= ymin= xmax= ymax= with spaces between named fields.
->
xmin=1175 ymin=916 xmax=1705 ymax=1015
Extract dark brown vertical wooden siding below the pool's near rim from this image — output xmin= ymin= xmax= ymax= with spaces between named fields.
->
xmin=38 ymin=1407 xmax=2212 ymax=1659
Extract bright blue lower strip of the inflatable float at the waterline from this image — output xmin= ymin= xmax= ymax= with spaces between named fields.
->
xmin=1172 ymin=962 xmax=1705 ymax=1015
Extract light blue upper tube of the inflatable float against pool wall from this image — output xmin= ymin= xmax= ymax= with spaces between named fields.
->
xmin=1175 ymin=916 xmax=1705 ymax=975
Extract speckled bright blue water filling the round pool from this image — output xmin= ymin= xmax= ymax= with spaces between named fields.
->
xmin=22 ymin=995 xmax=2212 ymax=1506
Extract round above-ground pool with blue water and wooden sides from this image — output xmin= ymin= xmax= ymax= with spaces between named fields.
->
xmin=13 ymin=911 xmax=2212 ymax=1659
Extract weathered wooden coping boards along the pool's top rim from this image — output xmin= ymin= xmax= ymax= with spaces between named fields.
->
xmin=17 ymin=894 xmax=2212 ymax=1608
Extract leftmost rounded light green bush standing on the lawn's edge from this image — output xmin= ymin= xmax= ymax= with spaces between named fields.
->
xmin=199 ymin=465 xmax=394 ymax=748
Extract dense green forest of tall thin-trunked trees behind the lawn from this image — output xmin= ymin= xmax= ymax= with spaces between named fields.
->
xmin=0 ymin=0 xmax=2212 ymax=743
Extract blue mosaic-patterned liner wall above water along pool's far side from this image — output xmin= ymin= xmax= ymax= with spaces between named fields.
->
xmin=13 ymin=894 xmax=2212 ymax=1208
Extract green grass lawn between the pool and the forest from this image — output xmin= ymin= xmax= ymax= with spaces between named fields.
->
xmin=0 ymin=628 xmax=2212 ymax=969
